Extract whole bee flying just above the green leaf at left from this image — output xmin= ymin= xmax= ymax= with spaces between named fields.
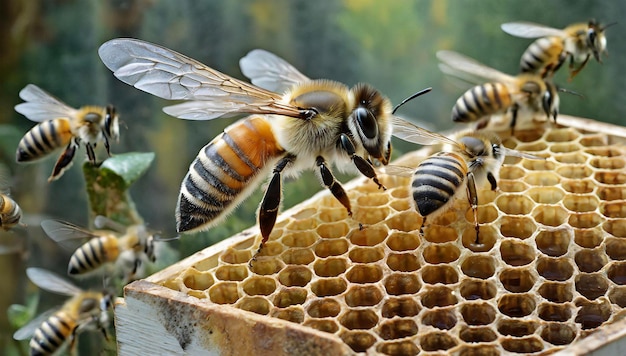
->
xmin=15 ymin=84 xmax=119 ymax=181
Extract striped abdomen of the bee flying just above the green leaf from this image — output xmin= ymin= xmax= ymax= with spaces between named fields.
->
xmin=16 ymin=118 xmax=73 ymax=162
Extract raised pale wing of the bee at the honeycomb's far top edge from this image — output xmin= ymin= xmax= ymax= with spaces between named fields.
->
xmin=437 ymin=51 xmax=515 ymax=83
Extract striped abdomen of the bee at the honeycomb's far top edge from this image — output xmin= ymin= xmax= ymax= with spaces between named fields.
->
xmin=452 ymin=83 xmax=513 ymax=122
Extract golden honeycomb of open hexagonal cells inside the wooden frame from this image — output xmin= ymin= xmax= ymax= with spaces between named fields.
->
xmin=119 ymin=115 xmax=626 ymax=355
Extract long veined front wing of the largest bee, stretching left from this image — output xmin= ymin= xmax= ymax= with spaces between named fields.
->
xmin=98 ymin=38 xmax=301 ymax=120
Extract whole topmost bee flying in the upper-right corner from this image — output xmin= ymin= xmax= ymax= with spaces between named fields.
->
xmin=500 ymin=19 xmax=614 ymax=80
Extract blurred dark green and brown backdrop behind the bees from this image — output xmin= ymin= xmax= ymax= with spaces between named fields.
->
xmin=0 ymin=0 xmax=626 ymax=353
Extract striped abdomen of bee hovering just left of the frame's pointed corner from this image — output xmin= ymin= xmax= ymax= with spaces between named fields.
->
xmin=67 ymin=235 xmax=120 ymax=275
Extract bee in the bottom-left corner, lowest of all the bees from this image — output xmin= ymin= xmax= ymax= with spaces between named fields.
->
xmin=13 ymin=267 xmax=112 ymax=356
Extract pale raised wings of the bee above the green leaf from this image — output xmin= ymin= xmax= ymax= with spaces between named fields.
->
xmin=15 ymin=84 xmax=77 ymax=122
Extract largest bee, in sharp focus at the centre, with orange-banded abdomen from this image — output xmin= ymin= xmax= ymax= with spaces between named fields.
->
xmin=99 ymin=39 xmax=436 ymax=253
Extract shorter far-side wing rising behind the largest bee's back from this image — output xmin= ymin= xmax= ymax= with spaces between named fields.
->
xmin=239 ymin=49 xmax=311 ymax=93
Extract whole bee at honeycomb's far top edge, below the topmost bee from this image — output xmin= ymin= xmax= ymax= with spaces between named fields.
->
xmin=437 ymin=51 xmax=559 ymax=132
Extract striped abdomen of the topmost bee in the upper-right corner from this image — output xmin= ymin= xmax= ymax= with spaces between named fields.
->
xmin=520 ymin=37 xmax=565 ymax=76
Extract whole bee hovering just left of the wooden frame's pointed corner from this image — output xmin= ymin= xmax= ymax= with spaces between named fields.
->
xmin=41 ymin=216 xmax=156 ymax=282
